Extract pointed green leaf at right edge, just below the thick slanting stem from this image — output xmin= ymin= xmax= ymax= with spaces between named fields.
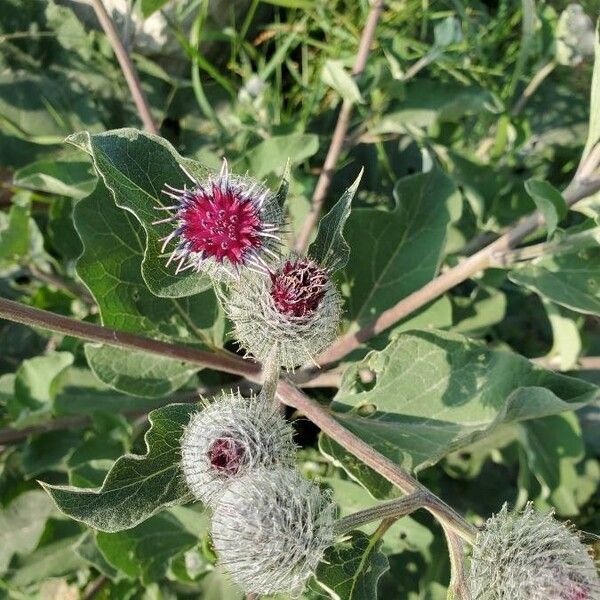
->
xmin=509 ymin=247 xmax=600 ymax=315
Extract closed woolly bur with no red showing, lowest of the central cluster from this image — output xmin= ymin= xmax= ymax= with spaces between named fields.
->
xmin=212 ymin=467 xmax=335 ymax=595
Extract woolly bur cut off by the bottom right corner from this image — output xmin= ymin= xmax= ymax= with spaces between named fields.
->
xmin=469 ymin=505 xmax=600 ymax=600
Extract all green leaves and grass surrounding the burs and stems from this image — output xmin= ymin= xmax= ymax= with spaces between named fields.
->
xmin=0 ymin=0 xmax=600 ymax=600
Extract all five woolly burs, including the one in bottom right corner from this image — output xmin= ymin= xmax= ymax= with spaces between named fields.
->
xmin=157 ymin=163 xmax=600 ymax=600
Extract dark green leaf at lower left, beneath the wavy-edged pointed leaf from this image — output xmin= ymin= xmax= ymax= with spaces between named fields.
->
xmin=96 ymin=512 xmax=198 ymax=584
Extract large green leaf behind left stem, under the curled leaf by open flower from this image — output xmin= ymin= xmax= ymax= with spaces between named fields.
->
xmin=75 ymin=182 xmax=224 ymax=397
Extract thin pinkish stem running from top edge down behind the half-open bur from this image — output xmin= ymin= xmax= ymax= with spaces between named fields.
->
xmin=295 ymin=0 xmax=384 ymax=253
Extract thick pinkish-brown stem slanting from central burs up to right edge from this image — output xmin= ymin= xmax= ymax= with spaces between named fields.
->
xmin=317 ymin=175 xmax=600 ymax=367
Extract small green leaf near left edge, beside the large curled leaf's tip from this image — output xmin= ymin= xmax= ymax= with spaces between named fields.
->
xmin=13 ymin=160 xmax=97 ymax=200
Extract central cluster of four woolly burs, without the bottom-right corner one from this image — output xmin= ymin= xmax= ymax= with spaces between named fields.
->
xmin=162 ymin=163 xmax=341 ymax=595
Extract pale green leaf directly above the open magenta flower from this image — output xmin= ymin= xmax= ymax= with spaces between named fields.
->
xmin=246 ymin=133 xmax=319 ymax=179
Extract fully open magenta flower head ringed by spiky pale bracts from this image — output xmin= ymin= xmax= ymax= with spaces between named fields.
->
xmin=155 ymin=161 xmax=283 ymax=279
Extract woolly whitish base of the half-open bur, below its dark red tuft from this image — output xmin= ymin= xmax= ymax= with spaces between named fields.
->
xmin=225 ymin=262 xmax=342 ymax=370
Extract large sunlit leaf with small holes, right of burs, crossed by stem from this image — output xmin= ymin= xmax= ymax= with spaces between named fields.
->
xmin=321 ymin=331 xmax=598 ymax=496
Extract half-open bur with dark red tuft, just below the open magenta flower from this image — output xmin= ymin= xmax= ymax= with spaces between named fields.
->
xmin=226 ymin=257 xmax=341 ymax=369
